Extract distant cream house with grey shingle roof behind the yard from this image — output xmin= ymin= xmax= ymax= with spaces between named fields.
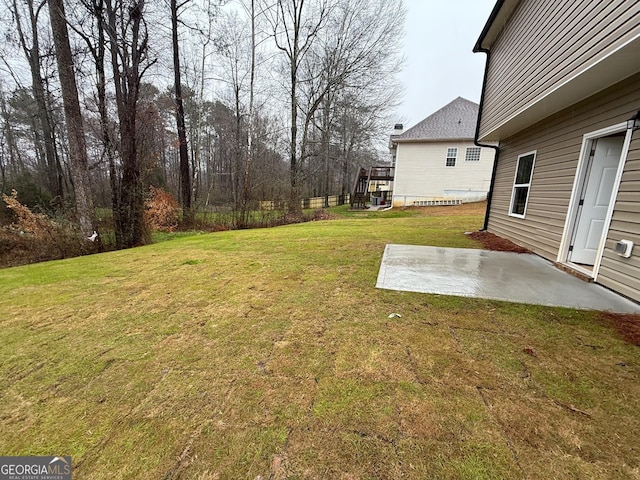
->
xmin=390 ymin=97 xmax=495 ymax=206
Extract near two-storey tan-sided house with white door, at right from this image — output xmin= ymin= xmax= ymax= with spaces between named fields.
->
xmin=474 ymin=0 xmax=640 ymax=301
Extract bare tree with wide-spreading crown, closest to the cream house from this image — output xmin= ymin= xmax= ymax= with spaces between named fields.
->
xmin=301 ymin=0 xmax=405 ymax=196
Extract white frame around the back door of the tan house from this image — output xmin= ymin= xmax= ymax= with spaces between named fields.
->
xmin=557 ymin=122 xmax=632 ymax=281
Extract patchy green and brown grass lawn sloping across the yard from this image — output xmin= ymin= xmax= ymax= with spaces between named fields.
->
xmin=0 ymin=205 xmax=640 ymax=480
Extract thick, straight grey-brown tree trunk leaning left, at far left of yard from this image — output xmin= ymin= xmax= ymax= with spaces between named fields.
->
xmin=49 ymin=0 xmax=94 ymax=236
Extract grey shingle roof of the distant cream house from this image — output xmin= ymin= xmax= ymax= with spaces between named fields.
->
xmin=392 ymin=97 xmax=479 ymax=142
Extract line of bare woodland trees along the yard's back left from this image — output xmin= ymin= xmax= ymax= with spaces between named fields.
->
xmin=0 ymin=0 xmax=404 ymax=248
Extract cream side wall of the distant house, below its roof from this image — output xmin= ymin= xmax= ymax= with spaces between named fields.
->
xmin=393 ymin=141 xmax=494 ymax=206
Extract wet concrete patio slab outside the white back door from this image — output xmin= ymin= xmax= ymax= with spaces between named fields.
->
xmin=376 ymin=244 xmax=640 ymax=313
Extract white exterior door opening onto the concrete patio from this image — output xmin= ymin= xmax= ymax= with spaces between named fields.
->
xmin=569 ymin=136 xmax=624 ymax=265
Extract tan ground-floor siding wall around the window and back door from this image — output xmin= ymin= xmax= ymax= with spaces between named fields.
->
xmin=488 ymin=74 xmax=640 ymax=300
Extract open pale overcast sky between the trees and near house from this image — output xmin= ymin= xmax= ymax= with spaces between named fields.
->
xmin=395 ymin=0 xmax=495 ymax=130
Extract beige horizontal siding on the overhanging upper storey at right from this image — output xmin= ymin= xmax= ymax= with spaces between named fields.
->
xmin=480 ymin=0 xmax=640 ymax=138
